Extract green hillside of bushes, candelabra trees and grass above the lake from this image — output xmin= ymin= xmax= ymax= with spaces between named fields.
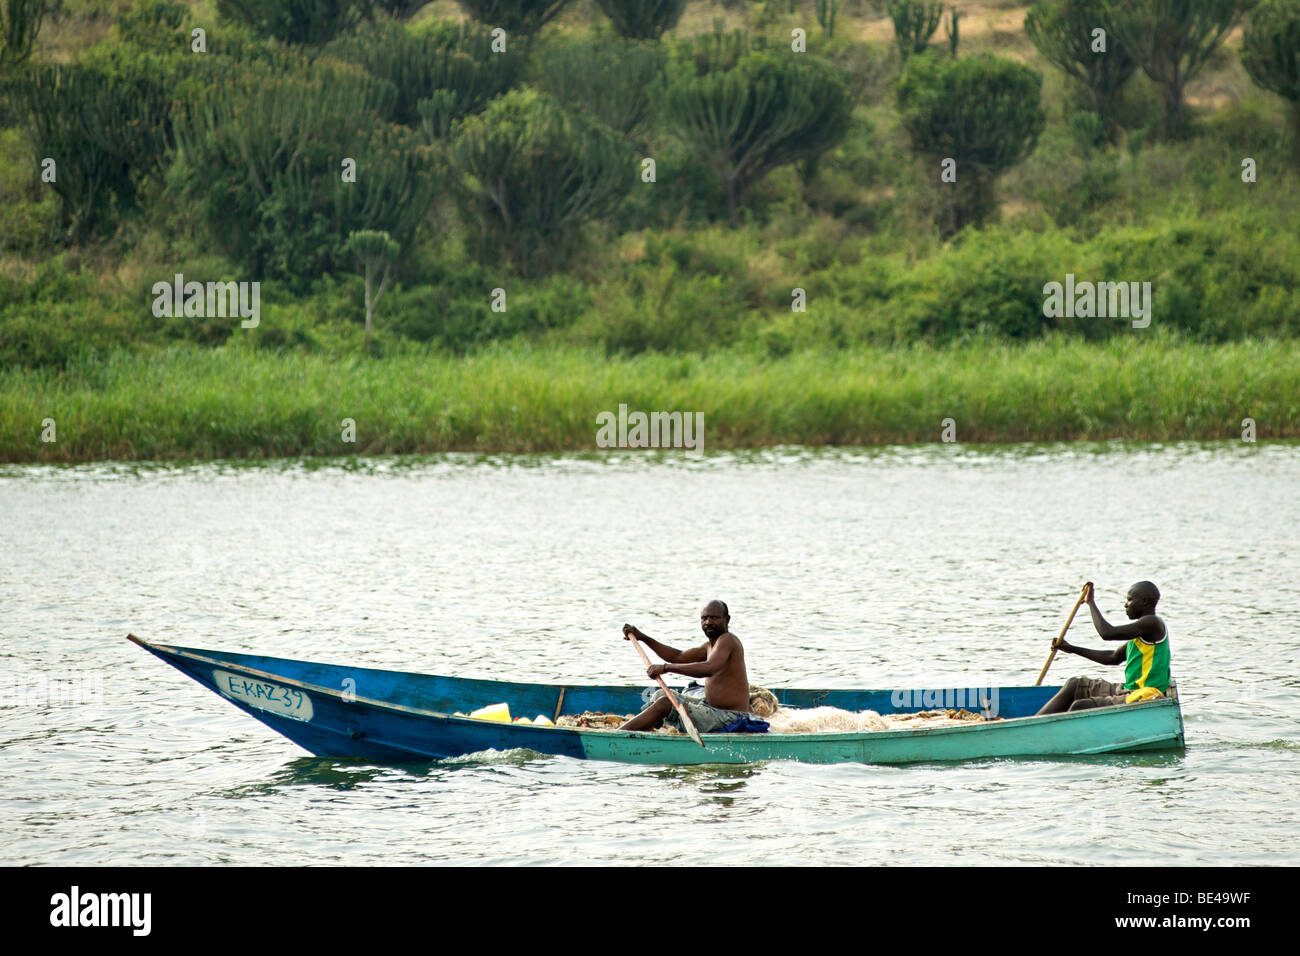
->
xmin=0 ymin=0 xmax=1300 ymax=460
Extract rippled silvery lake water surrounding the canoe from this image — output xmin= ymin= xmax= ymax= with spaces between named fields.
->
xmin=0 ymin=442 xmax=1300 ymax=865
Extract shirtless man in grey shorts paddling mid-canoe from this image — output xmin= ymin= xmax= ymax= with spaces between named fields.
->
xmin=619 ymin=601 xmax=749 ymax=734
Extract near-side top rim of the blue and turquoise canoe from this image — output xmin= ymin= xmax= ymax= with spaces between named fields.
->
xmin=126 ymin=635 xmax=1183 ymax=752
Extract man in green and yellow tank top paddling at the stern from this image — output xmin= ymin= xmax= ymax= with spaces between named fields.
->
xmin=1037 ymin=581 xmax=1169 ymax=717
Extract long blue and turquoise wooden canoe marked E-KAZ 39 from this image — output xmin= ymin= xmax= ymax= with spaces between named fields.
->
xmin=129 ymin=635 xmax=1183 ymax=763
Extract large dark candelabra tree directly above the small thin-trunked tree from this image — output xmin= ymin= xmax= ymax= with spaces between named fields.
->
xmin=172 ymin=55 xmax=441 ymax=277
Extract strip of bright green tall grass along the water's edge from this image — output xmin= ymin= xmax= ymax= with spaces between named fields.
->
xmin=0 ymin=336 xmax=1300 ymax=463
